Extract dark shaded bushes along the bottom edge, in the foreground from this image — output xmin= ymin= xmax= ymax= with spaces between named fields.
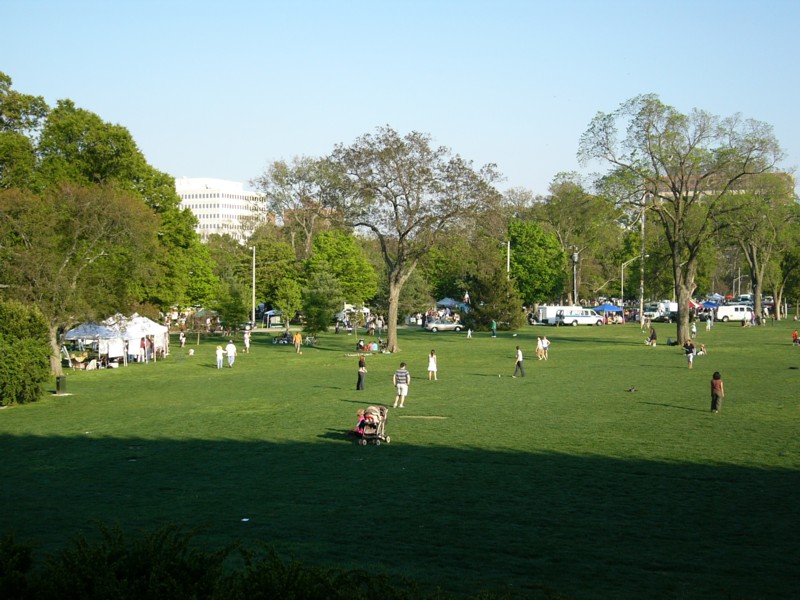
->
xmin=0 ymin=525 xmax=532 ymax=600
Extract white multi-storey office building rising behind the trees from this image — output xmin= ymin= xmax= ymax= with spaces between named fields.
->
xmin=175 ymin=177 xmax=263 ymax=243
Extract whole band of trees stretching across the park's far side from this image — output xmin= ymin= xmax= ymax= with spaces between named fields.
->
xmin=0 ymin=72 xmax=800 ymax=404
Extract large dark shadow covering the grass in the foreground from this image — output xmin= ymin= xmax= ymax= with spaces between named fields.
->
xmin=0 ymin=434 xmax=800 ymax=598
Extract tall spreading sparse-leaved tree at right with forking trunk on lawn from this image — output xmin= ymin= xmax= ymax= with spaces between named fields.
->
xmin=578 ymin=95 xmax=782 ymax=340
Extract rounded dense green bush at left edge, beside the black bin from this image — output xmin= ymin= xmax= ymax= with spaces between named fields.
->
xmin=0 ymin=300 xmax=51 ymax=405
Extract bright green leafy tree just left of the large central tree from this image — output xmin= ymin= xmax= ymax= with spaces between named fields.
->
xmin=306 ymin=231 xmax=378 ymax=306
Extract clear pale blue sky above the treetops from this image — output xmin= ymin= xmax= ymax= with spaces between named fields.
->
xmin=0 ymin=0 xmax=800 ymax=194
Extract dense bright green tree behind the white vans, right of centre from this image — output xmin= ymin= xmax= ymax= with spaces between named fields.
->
xmin=508 ymin=220 xmax=566 ymax=305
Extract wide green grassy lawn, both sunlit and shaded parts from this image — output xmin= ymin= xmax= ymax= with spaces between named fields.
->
xmin=0 ymin=322 xmax=800 ymax=598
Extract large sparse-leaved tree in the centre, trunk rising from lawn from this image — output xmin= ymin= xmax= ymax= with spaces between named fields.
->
xmin=331 ymin=127 xmax=499 ymax=352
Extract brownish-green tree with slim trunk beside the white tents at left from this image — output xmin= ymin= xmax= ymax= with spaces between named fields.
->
xmin=0 ymin=184 xmax=158 ymax=375
